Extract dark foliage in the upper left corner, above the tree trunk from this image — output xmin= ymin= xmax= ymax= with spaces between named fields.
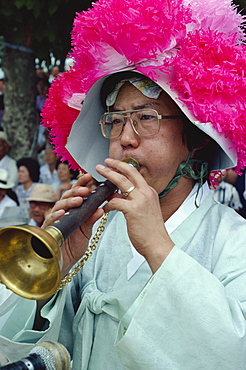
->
xmin=0 ymin=0 xmax=91 ymax=66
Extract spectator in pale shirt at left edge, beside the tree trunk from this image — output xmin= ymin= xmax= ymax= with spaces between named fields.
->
xmin=0 ymin=131 xmax=18 ymax=186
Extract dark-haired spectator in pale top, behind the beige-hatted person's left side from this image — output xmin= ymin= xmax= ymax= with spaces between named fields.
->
xmin=15 ymin=157 xmax=40 ymax=209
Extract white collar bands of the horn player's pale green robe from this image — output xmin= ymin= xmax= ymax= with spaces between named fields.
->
xmin=127 ymin=182 xmax=210 ymax=280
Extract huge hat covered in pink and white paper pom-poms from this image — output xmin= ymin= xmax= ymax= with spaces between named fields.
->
xmin=42 ymin=0 xmax=246 ymax=184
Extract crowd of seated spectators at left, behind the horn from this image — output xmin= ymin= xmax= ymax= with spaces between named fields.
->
xmin=0 ymin=121 xmax=79 ymax=228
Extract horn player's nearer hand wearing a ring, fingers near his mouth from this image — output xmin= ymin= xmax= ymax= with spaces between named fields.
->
xmin=96 ymin=158 xmax=174 ymax=273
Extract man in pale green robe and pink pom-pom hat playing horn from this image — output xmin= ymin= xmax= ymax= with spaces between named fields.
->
xmin=0 ymin=0 xmax=246 ymax=370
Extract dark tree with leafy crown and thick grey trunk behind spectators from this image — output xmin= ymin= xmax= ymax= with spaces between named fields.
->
xmin=0 ymin=0 xmax=91 ymax=159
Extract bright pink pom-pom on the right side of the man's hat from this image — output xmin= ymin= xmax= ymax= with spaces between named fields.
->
xmin=170 ymin=30 xmax=246 ymax=171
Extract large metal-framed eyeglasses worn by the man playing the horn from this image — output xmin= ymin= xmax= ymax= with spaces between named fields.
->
xmin=99 ymin=109 xmax=182 ymax=139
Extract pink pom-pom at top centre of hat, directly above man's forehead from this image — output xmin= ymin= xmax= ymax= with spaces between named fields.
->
xmin=71 ymin=0 xmax=192 ymax=89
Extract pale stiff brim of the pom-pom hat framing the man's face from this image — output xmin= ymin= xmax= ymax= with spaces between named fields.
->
xmin=66 ymin=69 xmax=237 ymax=181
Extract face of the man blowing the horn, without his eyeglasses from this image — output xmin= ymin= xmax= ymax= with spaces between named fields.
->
xmin=109 ymin=83 xmax=189 ymax=193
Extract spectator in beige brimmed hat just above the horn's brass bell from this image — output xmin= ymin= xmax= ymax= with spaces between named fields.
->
xmin=26 ymin=184 xmax=56 ymax=227
